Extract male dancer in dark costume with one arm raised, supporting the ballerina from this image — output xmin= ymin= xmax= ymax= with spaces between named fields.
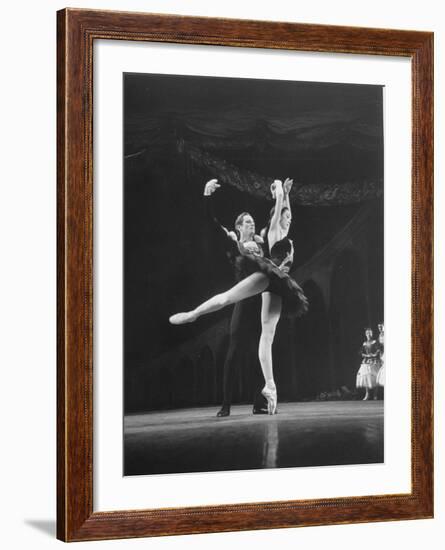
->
xmin=204 ymin=179 xmax=268 ymax=417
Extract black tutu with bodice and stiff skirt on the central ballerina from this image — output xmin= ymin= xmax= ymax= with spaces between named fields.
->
xmin=237 ymin=238 xmax=309 ymax=317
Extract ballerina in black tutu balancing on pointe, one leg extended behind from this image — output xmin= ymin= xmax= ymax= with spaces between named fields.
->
xmin=169 ymin=180 xmax=308 ymax=414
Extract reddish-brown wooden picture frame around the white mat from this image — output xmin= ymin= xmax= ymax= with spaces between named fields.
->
xmin=57 ymin=9 xmax=433 ymax=541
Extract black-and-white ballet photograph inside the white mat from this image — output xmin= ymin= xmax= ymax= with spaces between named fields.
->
xmin=123 ymin=73 xmax=385 ymax=476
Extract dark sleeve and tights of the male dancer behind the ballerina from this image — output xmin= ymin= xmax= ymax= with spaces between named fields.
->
xmin=204 ymin=195 xmax=267 ymax=417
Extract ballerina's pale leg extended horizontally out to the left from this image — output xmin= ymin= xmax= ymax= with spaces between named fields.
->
xmin=169 ymin=273 xmax=269 ymax=325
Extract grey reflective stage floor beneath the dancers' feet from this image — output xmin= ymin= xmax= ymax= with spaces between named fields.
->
xmin=124 ymin=401 xmax=384 ymax=475
